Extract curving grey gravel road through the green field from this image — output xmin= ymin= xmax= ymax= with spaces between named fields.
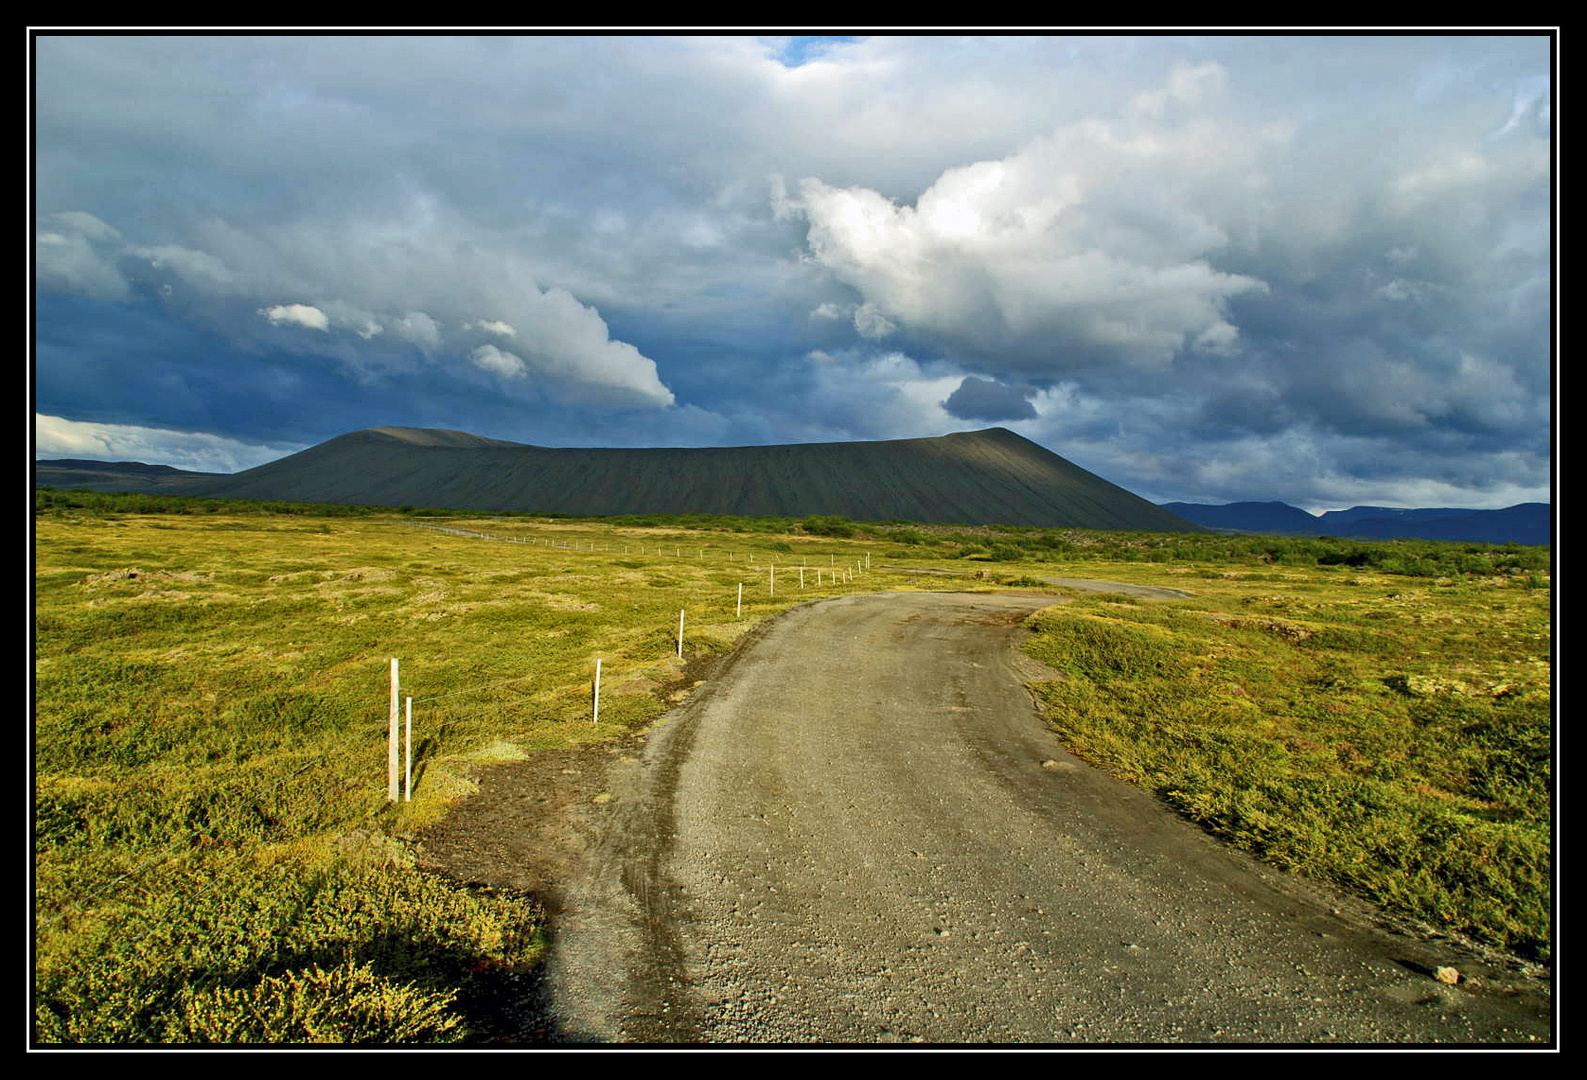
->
xmin=549 ymin=593 xmax=1550 ymax=1044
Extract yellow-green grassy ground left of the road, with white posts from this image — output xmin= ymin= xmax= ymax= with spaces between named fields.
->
xmin=33 ymin=493 xmax=920 ymax=1044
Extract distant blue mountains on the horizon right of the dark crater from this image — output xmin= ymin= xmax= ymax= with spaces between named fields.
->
xmin=1163 ymin=503 xmax=1554 ymax=544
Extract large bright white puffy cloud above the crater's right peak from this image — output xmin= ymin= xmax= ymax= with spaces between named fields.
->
xmin=786 ymin=73 xmax=1268 ymax=374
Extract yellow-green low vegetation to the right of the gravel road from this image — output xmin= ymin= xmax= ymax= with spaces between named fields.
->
xmin=1027 ymin=573 xmax=1554 ymax=959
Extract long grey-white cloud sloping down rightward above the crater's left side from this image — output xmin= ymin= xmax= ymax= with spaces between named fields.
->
xmin=37 ymin=192 xmax=674 ymax=408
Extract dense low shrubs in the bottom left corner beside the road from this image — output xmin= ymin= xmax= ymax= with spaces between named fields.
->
xmin=35 ymin=855 xmax=544 ymax=1044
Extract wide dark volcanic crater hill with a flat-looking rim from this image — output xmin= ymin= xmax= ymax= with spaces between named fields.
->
xmin=37 ymin=428 xmax=1203 ymax=533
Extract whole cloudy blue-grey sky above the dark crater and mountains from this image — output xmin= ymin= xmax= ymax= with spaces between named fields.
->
xmin=30 ymin=30 xmax=1555 ymax=512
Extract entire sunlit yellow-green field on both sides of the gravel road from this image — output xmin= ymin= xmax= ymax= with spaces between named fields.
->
xmin=33 ymin=492 xmax=1552 ymax=1044
